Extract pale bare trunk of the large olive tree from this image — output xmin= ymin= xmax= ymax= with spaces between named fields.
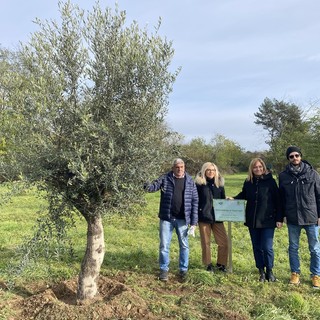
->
xmin=77 ymin=215 xmax=105 ymax=301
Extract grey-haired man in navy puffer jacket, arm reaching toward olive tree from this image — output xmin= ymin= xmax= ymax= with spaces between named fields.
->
xmin=144 ymin=159 xmax=199 ymax=281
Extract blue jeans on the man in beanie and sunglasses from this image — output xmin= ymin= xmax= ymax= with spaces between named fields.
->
xmin=288 ymin=224 xmax=320 ymax=276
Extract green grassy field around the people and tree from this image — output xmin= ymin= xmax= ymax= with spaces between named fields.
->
xmin=0 ymin=174 xmax=320 ymax=320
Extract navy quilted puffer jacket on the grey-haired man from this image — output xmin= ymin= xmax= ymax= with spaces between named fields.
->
xmin=145 ymin=171 xmax=199 ymax=226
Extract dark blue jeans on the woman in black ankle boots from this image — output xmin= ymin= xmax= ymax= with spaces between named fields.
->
xmin=249 ymin=228 xmax=274 ymax=269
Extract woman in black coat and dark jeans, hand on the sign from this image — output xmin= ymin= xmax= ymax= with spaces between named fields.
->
xmin=234 ymin=158 xmax=283 ymax=282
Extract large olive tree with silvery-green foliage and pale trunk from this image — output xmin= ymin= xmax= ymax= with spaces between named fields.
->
xmin=1 ymin=1 xmax=179 ymax=301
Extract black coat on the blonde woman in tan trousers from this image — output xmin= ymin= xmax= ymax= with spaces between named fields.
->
xmin=196 ymin=180 xmax=226 ymax=224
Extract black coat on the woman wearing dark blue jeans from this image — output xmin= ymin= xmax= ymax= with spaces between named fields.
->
xmin=234 ymin=173 xmax=283 ymax=228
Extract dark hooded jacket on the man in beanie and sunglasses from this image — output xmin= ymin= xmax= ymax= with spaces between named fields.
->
xmin=279 ymin=160 xmax=320 ymax=225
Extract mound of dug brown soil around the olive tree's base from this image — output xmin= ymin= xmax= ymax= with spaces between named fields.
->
xmin=0 ymin=276 xmax=159 ymax=320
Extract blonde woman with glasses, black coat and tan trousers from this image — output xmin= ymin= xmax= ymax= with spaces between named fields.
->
xmin=195 ymin=162 xmax=228 ymax=272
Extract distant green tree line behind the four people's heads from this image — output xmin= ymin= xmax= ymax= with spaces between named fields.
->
xmin=167 ymin=98 xmax=320 ymax=175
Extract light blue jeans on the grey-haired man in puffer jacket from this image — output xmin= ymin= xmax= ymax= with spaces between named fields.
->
xmin=159 ymin=219 xmax=189 ymax=271
